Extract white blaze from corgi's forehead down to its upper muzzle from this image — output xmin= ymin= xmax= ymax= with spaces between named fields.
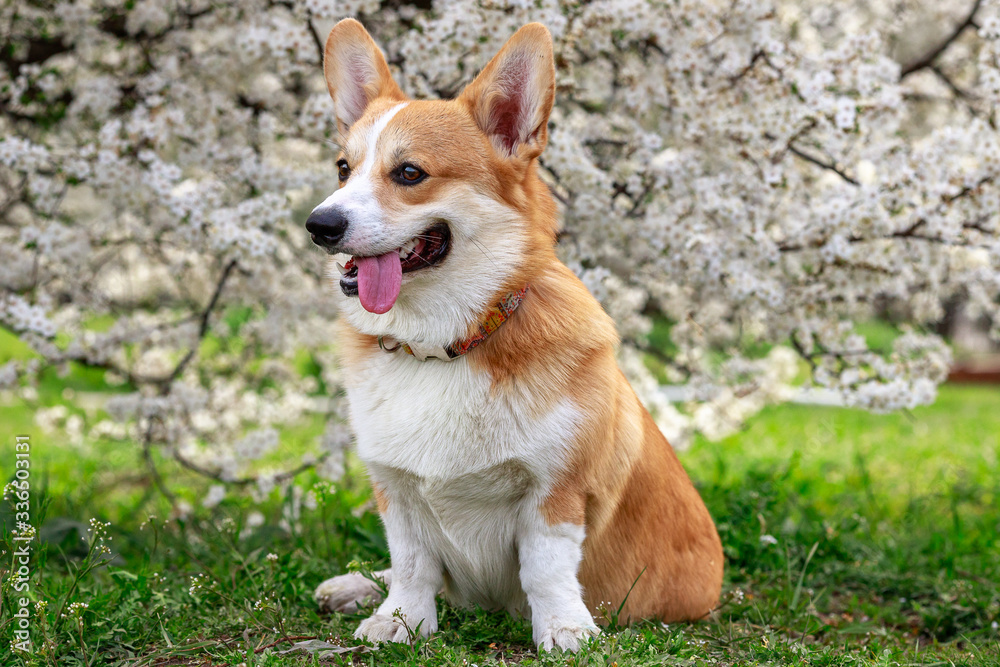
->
xmin=313 ymin=102 xmax=409 ymax=255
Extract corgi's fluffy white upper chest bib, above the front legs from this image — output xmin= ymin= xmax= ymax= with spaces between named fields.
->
xmin=347 ymin=353 xmax=578 ymax=479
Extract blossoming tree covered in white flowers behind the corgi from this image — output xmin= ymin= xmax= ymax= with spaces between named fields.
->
xmin=0 ymin=0 xmax=1000 ymax=503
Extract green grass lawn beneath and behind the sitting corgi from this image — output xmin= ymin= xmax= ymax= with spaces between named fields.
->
xmin=0 ymin=384 xmax=1000 ymax=667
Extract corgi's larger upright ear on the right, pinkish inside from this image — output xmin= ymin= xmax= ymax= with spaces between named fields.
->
xmin=458 ymin=23 xmax=556 ymax=160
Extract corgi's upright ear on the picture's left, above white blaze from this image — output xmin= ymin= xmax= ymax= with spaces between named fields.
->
xmin=323 ymin=19 xmax=406 ymax=136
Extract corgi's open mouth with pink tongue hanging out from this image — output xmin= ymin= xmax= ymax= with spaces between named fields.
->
xmin=337 ymin=222 xmax=451 ymax=315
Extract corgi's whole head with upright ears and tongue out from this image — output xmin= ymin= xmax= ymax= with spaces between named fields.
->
xmin=306 ymin=19 xmax=556 ymax=345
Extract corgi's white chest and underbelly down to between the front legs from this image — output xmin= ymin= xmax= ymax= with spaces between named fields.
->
xmin=348 ymin=358 xmax=578 ymax=609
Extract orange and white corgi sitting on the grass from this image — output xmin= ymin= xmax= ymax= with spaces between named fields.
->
xmin=306 ymin=19 xmax=723 ymax=651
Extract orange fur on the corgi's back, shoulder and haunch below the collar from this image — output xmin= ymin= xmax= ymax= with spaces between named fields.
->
xmin=469 ymin=258 xmax=723 ymax=622
